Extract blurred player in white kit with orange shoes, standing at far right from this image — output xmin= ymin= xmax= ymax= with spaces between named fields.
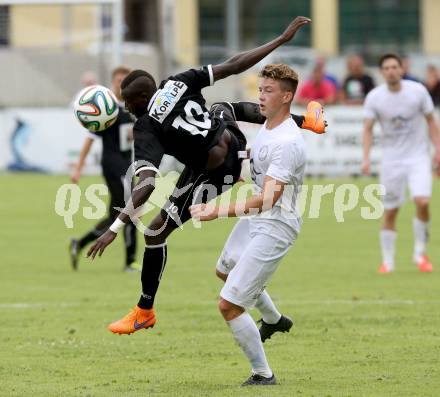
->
xmin=362 ymin=54 xmax=440 ymax=273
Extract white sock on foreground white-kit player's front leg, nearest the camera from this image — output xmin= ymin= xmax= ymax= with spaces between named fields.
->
xmin=227 ymin=312 xmax=272 ymax=378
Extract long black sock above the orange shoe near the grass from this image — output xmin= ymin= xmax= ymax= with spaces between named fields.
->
xmin=138 ymin=243 xmax=167 ymax=309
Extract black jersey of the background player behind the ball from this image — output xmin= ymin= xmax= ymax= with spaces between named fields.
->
xmin=92 ymin=106 xmax=134 ymax=166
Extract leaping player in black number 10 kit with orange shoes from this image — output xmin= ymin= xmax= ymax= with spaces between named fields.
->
xmin=87 ymin=17 xmax=321 ymax=334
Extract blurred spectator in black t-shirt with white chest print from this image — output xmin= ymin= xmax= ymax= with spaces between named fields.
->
xmin=341 ymin=55 xmax=374 ymax=105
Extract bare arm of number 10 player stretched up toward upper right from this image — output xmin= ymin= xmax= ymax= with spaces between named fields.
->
xmin=212 ymin=17 xmax=311 ymax=81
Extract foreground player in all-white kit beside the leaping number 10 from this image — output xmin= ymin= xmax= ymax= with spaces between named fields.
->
xmin=190 ymin=64 xmax=308 ymax=385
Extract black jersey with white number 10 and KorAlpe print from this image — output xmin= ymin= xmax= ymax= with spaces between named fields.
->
xmin=133 ymin=65 xmax=226 ymax=173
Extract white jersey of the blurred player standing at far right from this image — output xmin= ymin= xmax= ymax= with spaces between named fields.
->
xmin=364 ymin=80 xmax=434 ymax=162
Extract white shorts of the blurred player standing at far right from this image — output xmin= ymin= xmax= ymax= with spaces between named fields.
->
xmin=380 ymin=157 xmax=432 ymax=209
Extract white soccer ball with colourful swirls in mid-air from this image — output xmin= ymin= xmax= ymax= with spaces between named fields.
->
xmin=73 ymin=85 xmax=119 ymax=132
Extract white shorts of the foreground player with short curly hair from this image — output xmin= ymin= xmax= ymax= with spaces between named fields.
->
xmin=217 ymin=218 xmax=296 ymax=308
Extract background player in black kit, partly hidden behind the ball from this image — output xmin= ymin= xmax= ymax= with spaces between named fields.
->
xmin=69 ymin=66 xmax=139 ymax=271
